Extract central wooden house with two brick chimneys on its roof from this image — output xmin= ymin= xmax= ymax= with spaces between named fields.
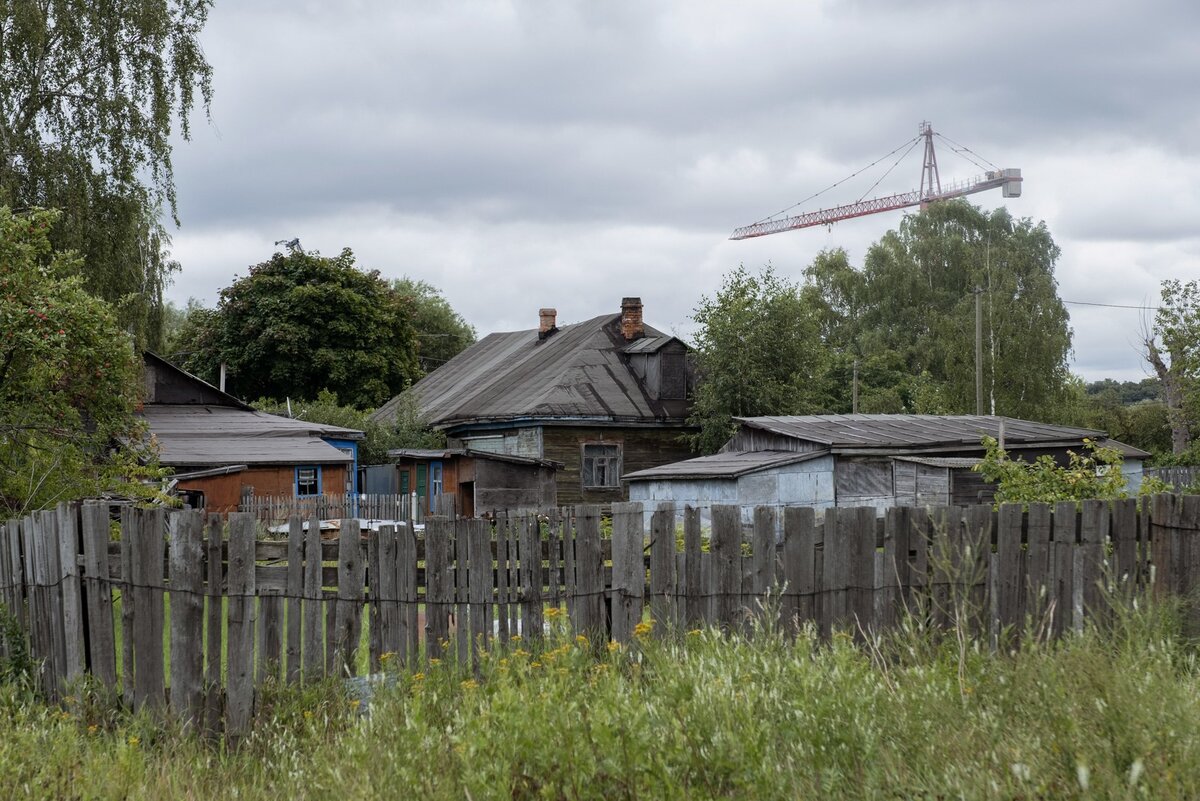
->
xmin=374 ymin=297 xmax=692 ymax=505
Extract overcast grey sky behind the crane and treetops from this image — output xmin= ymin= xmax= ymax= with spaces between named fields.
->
xmin=168 ymin=0 xmax=1200 ymax=380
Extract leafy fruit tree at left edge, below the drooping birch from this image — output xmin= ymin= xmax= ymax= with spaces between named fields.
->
xmin=0 ymin=206 xmax=142 ymax=514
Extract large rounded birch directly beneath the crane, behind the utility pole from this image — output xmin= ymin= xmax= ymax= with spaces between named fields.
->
xmin=859 ymin=201 xmax=1070 ymax=418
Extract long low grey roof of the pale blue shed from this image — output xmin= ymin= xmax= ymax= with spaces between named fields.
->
xmin=734 ymin=415 xmax=1106 ymax=450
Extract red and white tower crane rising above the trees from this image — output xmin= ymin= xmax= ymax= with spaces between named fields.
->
xmin=730 ymin=122 xmax=1021 ymax=240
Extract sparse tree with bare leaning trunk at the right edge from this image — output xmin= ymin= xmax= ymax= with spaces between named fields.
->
xmin=1142 ymin=279 xmax=1200 ymax=456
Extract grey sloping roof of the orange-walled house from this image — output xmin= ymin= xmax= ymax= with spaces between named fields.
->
xmin=142 ymin=404 xmax=362 ymax=466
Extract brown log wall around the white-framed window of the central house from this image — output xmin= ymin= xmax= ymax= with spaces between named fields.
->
xmin=541 ymin=426 xmax=694 ymax=506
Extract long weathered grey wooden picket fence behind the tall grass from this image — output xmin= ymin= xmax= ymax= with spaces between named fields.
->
xmin=0 ymin=495 xmax=1200 ymax=734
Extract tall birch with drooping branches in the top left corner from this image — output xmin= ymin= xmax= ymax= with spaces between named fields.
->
xmin=0 ymin=0 xmax=211 ymax=347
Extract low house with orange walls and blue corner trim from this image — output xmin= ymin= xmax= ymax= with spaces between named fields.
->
xmin=140 ymin=353 xmax=364 ymax=512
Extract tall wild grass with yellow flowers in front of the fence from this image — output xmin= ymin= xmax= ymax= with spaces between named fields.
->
xmin=0 ymin=604 xmax=1200 ymax=801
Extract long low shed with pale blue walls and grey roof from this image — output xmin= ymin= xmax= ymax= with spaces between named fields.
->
xmin=624 ymin=415 xmax=1150 ymax=522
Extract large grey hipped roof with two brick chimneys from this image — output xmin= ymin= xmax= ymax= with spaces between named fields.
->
xmin=373 ymin=314 xmax=682 ymax=427
